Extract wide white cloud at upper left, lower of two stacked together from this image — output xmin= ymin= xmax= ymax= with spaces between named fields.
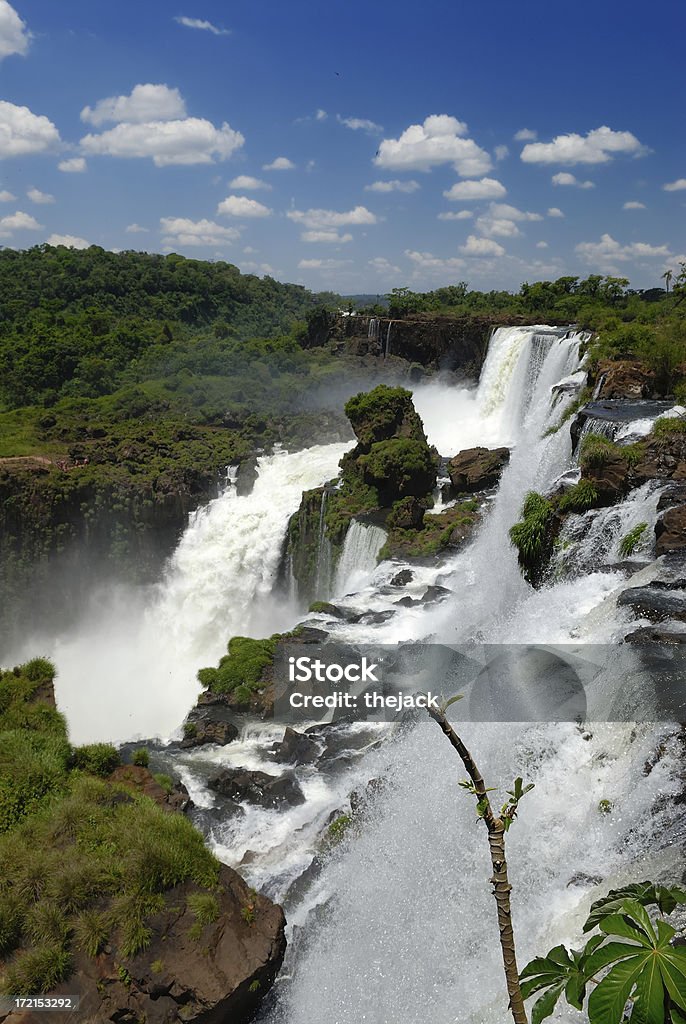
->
xmin=81 ymin=118 xmax=245 ymax=167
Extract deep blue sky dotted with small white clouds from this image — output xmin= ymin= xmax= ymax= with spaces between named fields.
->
xmin=0 ymin=0 xmax=686 ymax=293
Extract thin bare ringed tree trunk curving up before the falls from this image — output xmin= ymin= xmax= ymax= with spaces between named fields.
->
xmin=429 ymin=708 xmax=528 ymax=1024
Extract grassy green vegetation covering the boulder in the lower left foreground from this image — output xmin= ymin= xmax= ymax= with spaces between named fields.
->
xmin=0 ymin=658 xmax=219 ymax=994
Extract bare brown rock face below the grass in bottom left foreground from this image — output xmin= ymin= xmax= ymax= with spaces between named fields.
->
xmin=59 ymin=865 xmax=286 ymax=1024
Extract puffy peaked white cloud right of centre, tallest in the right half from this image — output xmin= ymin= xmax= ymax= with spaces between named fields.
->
xmin=374 ymin=114 xmax=492 ymax=178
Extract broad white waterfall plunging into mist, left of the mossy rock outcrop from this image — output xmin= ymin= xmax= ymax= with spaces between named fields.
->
xmin=8 ymin=444 xmax=349 ymax=742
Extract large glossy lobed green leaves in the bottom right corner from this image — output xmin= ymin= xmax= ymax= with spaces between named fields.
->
xmin=520 ymin=882 xmax=686 ymax=1024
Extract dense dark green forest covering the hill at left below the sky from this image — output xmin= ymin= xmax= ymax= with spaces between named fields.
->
xmin=0 ymin=246 xmax=340 ymax=409
